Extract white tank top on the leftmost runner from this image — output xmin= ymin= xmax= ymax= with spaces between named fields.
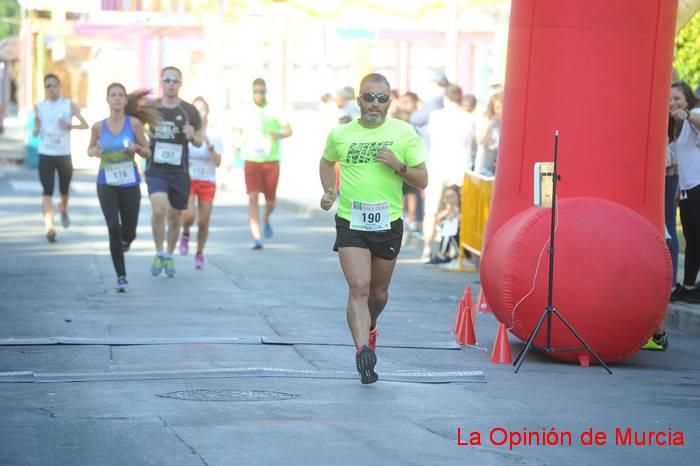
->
xmin=36 ymin=97 xmax=73 ymax=155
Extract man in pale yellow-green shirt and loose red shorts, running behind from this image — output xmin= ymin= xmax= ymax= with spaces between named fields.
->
xmin=243 ymin=78 xmax=292 ymax=249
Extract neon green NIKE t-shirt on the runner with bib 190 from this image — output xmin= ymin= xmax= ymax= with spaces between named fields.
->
xmin=323 ymin=118 xmax=425 ymax=222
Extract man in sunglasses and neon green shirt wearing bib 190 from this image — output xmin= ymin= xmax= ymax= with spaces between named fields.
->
xmin=319 ymin=73 xmax=428 ymax=384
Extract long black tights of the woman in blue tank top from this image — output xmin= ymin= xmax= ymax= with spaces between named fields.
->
xmin=97 ymin=184 xmax=141 ymax=277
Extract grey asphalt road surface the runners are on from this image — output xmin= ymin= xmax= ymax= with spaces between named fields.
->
xmin=0 ymin=165 xmax=700 ymax=465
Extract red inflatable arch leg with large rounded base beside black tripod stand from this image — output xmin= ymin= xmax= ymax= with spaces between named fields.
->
xmin=481 ymin=0 xmax=678 ymax=362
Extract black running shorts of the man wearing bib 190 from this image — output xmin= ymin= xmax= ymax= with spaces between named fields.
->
xmin=333 ymin=215 xmax=403 ymax=260
